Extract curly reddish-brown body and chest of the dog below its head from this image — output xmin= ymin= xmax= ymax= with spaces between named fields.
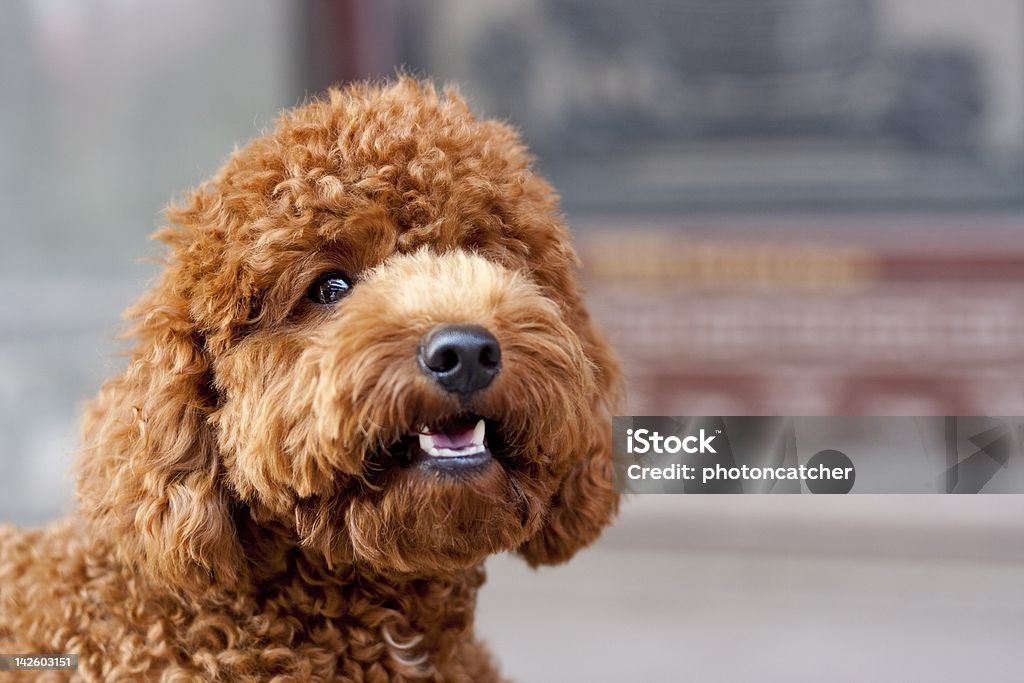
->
xmin=0 ymin=521 xmax=499 ymax=682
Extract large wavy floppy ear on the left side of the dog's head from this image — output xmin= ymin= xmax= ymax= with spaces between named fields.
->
xmin=77 ymin=210 xmax=244 ymax=590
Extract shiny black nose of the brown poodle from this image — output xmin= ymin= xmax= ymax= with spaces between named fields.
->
xmin=420 ymin=325 xmax=502 ymax=395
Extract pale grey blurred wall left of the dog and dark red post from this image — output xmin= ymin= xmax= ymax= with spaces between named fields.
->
xmin=0 ymin=0 xmax=301 ymax=522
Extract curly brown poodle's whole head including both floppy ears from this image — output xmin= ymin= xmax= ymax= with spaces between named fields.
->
xmin=79 ymin=78 xmax=618 ymax=587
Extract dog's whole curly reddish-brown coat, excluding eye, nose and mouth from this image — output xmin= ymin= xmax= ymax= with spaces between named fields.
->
xmin=0 ymin=77 xmax=620 ymax=682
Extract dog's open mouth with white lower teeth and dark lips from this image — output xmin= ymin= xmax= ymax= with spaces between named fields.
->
xmin=393 ymin=415 xmax=499 ymax=470
